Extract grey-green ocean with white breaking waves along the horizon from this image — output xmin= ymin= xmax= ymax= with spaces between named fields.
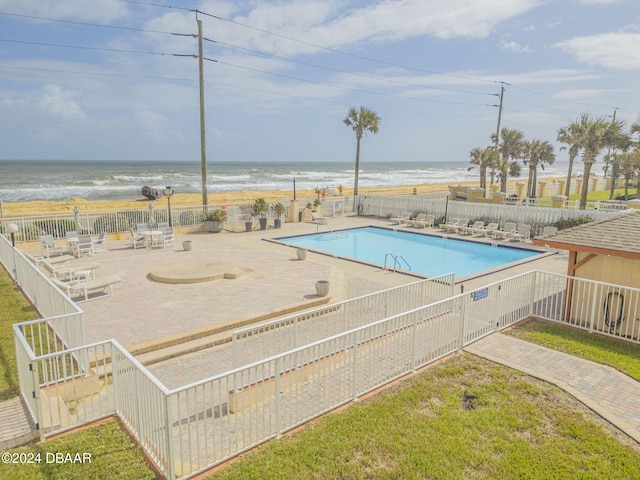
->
xmin=0 ymin=160 xmax=567 ymax=202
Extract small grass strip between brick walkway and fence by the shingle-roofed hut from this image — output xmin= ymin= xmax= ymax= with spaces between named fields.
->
xmin=505 ymin=320 xmax=640 ymax=381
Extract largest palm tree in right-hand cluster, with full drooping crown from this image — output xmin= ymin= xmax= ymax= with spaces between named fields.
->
xmin=580 ymin=114 xmax=623 ymax=210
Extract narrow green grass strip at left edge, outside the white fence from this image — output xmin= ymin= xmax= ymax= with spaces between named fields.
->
xmin=0 ymin=265 xmax=38 ymax=400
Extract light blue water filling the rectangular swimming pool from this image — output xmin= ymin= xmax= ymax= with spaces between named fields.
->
xmin=276 ymin=227 xmax=541 ymax=278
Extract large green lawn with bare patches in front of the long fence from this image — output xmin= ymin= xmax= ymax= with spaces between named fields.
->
xmin=209 ymin=354 xmax=640 ymax=480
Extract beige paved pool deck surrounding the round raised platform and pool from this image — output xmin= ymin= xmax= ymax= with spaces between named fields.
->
xmin=46 ymin=216 xmax=567 ymax=386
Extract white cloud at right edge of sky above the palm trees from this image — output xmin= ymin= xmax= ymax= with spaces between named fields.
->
xmin=553 ymin=33 xmax=640 ymax=70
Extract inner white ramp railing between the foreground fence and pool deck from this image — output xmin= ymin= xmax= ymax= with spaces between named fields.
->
xmin=231 ymin=273 xmax=455 ymax=367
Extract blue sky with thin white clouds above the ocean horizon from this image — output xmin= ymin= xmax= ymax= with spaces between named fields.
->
xmin=0 ymin=0 xmax=640 ymax=163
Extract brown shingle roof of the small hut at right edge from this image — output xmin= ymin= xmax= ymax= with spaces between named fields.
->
xmin=533 ymin=210 xmax=640 ymax=256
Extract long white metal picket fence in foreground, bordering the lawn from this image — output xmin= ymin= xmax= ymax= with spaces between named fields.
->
xmin=0 ymin=231 xmax=640 ymax=478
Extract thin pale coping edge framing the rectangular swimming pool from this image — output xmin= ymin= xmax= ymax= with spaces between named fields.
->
xmin=262 ymin=225 xmax=558 ymax=285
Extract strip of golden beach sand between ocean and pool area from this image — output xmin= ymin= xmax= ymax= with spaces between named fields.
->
xmin=2 ymin=179 xmax=553 ymax=217
